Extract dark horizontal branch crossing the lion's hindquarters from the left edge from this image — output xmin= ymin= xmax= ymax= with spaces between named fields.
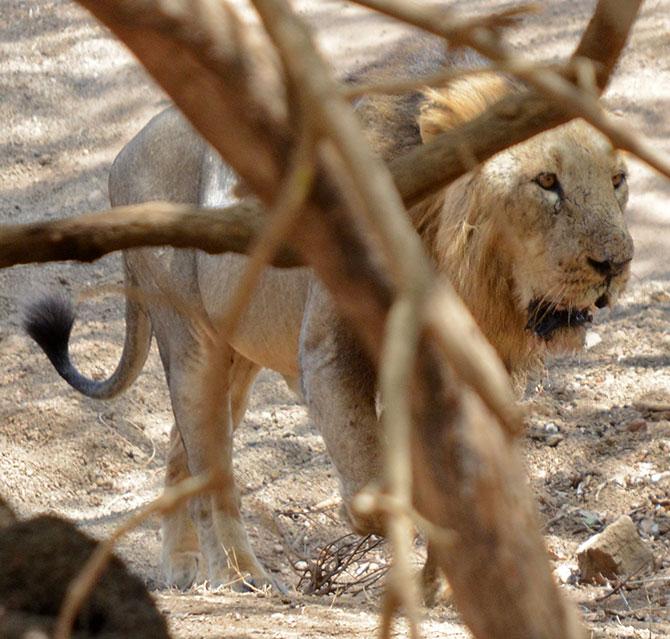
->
xmin=0 ymin=198 xmax=301 ymax=268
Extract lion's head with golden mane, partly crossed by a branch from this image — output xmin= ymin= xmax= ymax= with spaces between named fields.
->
xmin=413 ymin=76 xmax=633 ymax=373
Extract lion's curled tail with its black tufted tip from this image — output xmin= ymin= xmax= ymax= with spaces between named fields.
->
xmin=23 ymin=276 xmax=152 ymax=399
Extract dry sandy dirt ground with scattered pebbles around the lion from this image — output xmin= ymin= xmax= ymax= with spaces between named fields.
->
xmin=0 ymin=0 xmax=670 ymax=639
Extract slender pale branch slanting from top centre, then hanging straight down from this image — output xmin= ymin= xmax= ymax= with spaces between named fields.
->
xmin=243 ymin=15 xmax=431 ymax=639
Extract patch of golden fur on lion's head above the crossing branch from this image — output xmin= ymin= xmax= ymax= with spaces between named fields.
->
xmin=419 ymin=73 xmax=510 ymax=143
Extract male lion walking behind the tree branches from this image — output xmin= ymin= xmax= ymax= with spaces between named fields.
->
xmin=27 ymin=42 xmax=633 ymax=588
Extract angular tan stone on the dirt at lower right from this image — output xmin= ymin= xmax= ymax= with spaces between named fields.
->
xmin=577 ymin=515 xmax=654 ymax=582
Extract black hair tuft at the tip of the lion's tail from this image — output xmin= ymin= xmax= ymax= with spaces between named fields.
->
xmin=23 ymin=294 xmax=75 ymax=371
